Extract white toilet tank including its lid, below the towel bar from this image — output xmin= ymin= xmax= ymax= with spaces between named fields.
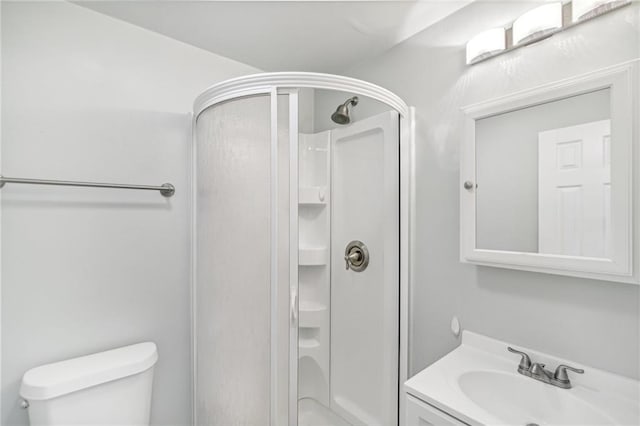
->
xmin=20 ymin=342 xmax=158 ymax=426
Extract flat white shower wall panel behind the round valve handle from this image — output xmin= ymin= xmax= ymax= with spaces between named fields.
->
xmin=330 ymin=112 xmax=400 ymax=426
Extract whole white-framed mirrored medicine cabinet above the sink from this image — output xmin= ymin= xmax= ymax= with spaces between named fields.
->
xmin=461 ymin=65 xmax=638 ymax=282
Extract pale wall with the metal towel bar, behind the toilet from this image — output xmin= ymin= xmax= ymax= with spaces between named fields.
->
xmin=0 ymin=2 xmax=258 ymax=426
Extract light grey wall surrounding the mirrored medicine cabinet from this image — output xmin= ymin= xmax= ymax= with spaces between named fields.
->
xmin=338 ymin=2 xmax=640 ymax=378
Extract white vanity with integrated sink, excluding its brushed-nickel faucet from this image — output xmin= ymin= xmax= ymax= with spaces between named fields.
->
xmin=404 ymin=330 xmax=640 ymax=426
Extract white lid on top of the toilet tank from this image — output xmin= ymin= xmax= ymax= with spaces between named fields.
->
xmin=20 ymin=342 xmax=158 ymax=400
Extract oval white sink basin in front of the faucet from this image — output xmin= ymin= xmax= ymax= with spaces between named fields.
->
xmin=458 ymin=371 xmax=616 ymax=426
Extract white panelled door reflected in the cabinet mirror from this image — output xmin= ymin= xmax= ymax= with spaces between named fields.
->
xmin=538 ymin=120 xmax=611 ymax=258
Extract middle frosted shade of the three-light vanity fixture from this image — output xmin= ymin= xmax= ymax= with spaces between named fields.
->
xmin=513 ymin=3 xmax=562 ymax=45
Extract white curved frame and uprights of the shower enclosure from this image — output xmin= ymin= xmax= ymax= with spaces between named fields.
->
xmin=190 ymin=72 xmax=415 ymax=426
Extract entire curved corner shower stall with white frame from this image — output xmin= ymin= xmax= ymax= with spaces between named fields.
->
xmin=192 ymin=73 xmax=413 ymax=426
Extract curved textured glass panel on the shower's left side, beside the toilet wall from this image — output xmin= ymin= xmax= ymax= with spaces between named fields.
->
xmin=195 ymin=96 xmax=271 ymax=426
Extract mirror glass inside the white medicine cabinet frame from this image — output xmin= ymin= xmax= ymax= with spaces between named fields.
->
xmin=476 ymin=89 xmax=611 ymax=258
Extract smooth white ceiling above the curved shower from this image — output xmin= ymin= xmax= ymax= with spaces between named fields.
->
xmin=74 ymin=0 xmax=473 ymax=72
